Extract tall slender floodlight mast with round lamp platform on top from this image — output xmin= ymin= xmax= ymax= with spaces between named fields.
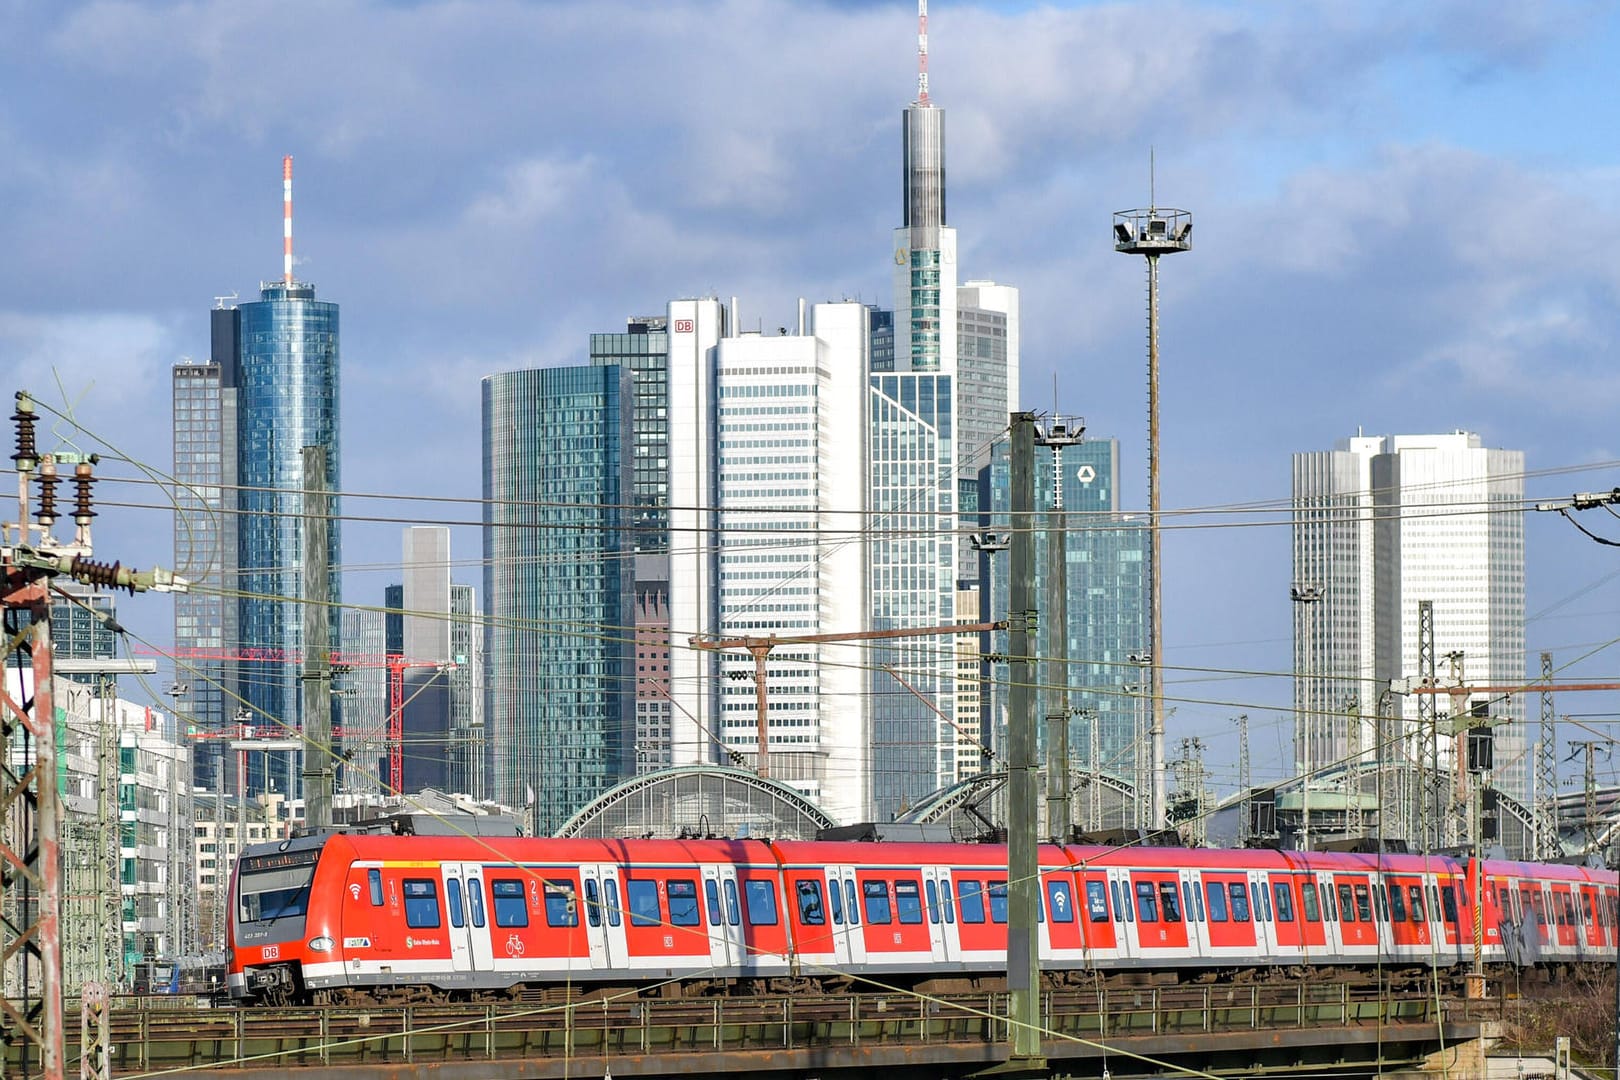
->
xmin=1113 ymin=177 xmax=1192 ymax=829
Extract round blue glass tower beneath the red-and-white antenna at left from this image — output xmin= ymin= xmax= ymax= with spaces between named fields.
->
xmin=237 ymin=282 xmax=342 ymax=793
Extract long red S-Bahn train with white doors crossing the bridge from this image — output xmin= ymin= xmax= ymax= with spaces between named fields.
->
xmin=227 ymin=832 xmax=1620 ymax=1004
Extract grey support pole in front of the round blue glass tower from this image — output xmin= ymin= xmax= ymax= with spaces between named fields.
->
xmin=298 ymin=447 xmax=334 ymax=829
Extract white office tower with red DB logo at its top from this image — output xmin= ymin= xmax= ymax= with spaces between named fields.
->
xmin=669 ymin=301 xmax=870 ymax=821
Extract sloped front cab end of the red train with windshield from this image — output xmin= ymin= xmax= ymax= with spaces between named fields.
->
xmin=225 ymin=836 xmax=348 ymax=1006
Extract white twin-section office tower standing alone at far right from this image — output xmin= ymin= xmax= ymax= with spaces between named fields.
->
xmin=1293 ymin=431 xmax=1529 ymax=800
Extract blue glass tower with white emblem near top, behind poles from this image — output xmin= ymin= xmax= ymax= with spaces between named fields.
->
xmin=990 ymin=439 xmax=1149 ymax=803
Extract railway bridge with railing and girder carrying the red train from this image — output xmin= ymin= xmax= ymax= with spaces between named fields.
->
xmin=28 ymin=983 xmax=1502 ymax=1080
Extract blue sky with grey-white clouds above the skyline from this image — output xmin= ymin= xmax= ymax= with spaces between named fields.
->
xmin=0 ymin=0 xmax=1620 ymax=784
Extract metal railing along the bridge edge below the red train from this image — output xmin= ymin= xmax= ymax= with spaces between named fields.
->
xmin=19 ymin=983 xmax=1500 ymax=1075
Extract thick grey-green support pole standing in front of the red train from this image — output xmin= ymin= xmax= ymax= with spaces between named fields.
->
xmin=1008 ymin=413 xmax=1045 ymax=1069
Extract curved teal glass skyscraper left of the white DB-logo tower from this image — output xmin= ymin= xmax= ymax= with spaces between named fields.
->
xmin=483 ymin=366 xmax=635 ymax=834
